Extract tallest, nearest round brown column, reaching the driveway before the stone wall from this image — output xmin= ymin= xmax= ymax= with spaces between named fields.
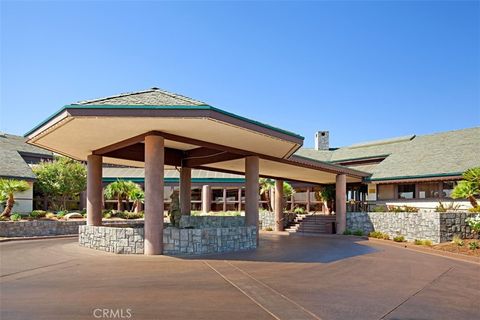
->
xmin=144 ymin=135 xmax=165 ymax=255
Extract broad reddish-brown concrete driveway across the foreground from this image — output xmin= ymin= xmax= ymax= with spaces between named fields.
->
xmin=0 ymin=234 xmax=480 ymax=320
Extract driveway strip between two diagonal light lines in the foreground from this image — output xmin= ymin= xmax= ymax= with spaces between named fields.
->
xmin=203 ymin=261 xmax=321 ymax=320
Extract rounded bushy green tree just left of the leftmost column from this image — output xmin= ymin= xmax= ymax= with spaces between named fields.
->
xmin=33 ymin=157 xmax=87 ymax=209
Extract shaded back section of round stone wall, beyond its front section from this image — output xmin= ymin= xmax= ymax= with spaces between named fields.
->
xmin=180 ymin=215 xmax=245 ymax=229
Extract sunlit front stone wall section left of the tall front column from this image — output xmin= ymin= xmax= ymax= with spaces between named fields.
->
xmin=78 ymin=225 xmax=144 ymax=254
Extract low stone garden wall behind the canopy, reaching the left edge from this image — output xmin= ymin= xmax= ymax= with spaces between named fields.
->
xmin=0 ymin=220 xmax=143 ymax=237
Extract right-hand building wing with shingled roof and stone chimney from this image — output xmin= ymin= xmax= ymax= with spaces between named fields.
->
xmin=296 ymin=127 xmax=480 ymax=209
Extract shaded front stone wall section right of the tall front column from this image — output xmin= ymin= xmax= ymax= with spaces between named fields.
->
xmin=163 ymin=227 xmax=257 ymax=255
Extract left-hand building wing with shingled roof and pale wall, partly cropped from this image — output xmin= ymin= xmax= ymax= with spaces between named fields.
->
xmin=0 ymin=133 xmax=53 ymax=213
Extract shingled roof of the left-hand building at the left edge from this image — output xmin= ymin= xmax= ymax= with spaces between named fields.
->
xmin=0 ymin=133 xmax=52 ymax=179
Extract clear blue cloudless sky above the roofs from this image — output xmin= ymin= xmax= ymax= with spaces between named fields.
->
xmin=0 ymin=0 xmax=480 ymax=147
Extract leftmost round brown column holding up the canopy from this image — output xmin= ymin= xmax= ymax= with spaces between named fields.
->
xmin=87 ymin=154 xmax=103 ymax=226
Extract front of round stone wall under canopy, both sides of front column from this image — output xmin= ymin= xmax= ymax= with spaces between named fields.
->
xmin=78 ymin=226 xmax=257 ymax=255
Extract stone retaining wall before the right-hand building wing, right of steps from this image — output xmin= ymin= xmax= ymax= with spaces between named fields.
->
xmin=347 ymin=212 xmax=473 ymax=243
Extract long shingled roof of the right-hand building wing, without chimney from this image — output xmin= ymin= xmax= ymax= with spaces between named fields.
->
xmin=296 ymin=127 xmax=480 ymax=181
